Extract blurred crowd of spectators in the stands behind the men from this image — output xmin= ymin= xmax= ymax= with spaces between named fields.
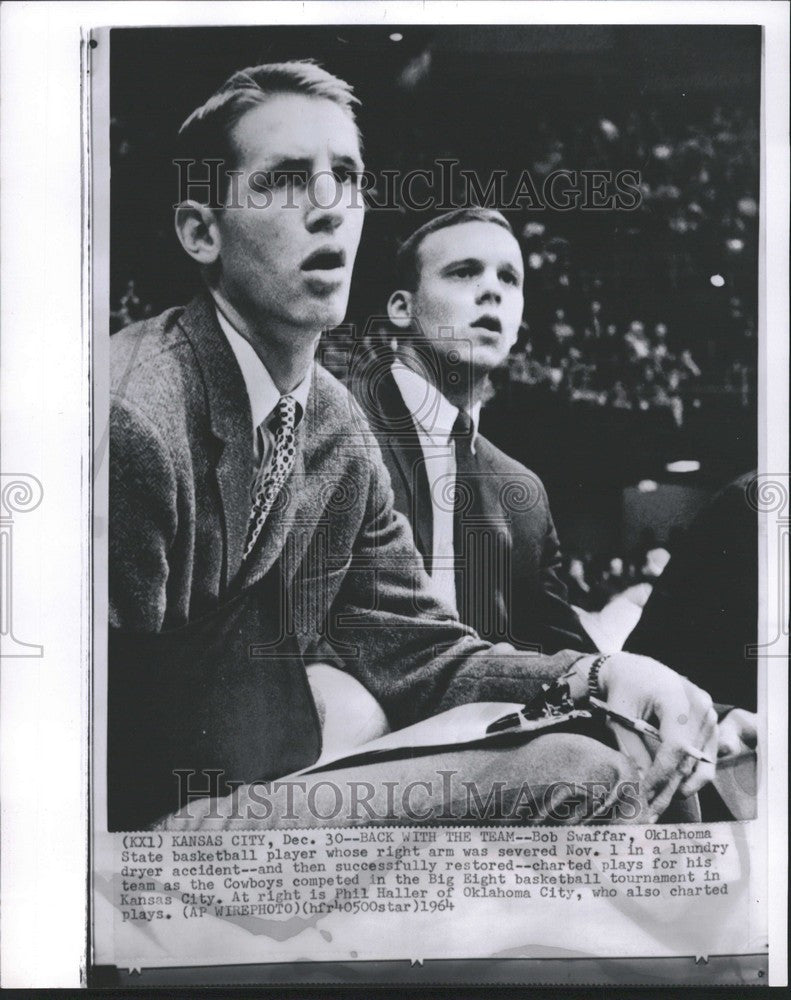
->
xmin=111 ymin=107 xmax=758 ymax=427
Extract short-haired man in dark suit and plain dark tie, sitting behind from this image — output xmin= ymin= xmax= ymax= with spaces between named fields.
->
xmin=352 ymin=208 xmax=595 ymax=653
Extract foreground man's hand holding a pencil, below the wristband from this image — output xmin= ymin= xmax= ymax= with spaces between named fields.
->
xmin=599 ymin=653 xmax=717 ymax=817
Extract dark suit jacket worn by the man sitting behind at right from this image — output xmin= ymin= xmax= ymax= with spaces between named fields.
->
xmin=354 ymin=368 xmax=595 ymax=653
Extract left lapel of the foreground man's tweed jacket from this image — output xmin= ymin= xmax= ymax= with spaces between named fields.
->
xmin=180 ymin=295 xmax=253 ymax=589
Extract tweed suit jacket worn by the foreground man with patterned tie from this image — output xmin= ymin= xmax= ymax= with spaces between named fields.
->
xmin=109 ymin=296 xmax=580 ymax=727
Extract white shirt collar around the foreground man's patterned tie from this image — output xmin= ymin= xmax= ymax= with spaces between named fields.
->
xmin=216 ymin=309 xmax=311 ymax=483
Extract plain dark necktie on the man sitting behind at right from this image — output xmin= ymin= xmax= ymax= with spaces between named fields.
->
xmin=451 ymin=410 xmax=485 ymax=629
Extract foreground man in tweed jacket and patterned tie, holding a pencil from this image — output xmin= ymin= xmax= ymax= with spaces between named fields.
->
xmin=108 ymin=63 xmax=716 ymax=829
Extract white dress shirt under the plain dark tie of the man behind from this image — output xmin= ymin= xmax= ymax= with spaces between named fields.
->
xmin=392 ymin=361 xmax=481 ymax=608
